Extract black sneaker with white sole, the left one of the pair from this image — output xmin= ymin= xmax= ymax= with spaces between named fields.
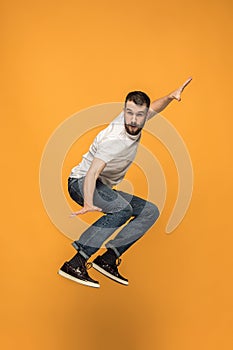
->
xmin=58 ymin=262 xmax=100 ymax=288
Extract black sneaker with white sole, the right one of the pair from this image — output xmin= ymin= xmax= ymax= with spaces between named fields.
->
xmin=92 ymin=255 xmax=129 ymax=286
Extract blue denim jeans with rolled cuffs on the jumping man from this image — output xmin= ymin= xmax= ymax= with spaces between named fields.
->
xmin=68 ymin=177 xmax=159 ymax=259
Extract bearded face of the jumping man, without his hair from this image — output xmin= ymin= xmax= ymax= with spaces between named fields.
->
xmin=124 ymin=101 xmax=148 ymax=135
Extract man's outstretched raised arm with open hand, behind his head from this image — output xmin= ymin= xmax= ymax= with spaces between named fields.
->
xmin=147 ymin=78 xmax=192 ymax=119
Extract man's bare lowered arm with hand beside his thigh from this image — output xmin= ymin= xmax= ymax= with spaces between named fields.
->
xmin=73 ymin=158 xmax=106 ymax=215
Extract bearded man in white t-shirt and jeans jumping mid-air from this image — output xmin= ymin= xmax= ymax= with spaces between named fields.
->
xmin=58 ymin=78 xmax=192 ymax=287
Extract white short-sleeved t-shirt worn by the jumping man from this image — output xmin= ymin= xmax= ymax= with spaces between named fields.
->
xmin=70 ymin=112 xmax=141 ymax=187
